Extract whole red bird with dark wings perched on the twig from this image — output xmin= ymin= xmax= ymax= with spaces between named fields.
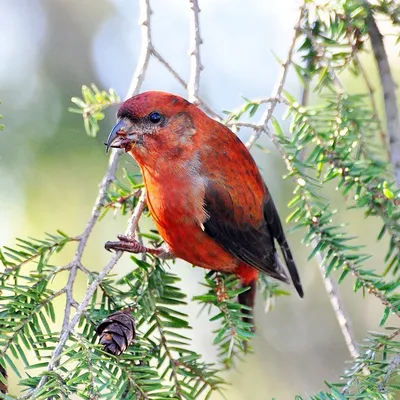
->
xmin=106 ymin=92 xmax=303 ymax=316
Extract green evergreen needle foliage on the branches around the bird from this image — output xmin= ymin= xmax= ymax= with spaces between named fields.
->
xmin=0 ymin=0 xmax=400 ymax=400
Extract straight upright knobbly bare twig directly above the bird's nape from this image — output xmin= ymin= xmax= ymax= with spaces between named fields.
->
xmin=187 ymin=0 xmax=203 ymax=104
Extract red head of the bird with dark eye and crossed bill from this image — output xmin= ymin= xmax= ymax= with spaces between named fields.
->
xmin=107 ymin=92 xmax=201 ymax=164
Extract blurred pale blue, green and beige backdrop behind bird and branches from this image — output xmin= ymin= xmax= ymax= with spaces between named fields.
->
xmin=0 ymin=0 xmax=400 ymax=400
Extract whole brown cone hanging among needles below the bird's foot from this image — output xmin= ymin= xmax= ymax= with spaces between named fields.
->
xmin=96 ymin=310 xmax=136 ymax=356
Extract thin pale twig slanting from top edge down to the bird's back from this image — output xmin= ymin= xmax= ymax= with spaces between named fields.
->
xmin=246 ymin=3 xmax=305 ymax=148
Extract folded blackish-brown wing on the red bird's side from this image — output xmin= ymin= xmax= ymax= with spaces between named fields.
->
xmin=203 ymin=181 xmax=287 ymax=282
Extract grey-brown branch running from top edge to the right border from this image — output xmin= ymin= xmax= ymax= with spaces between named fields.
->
xmin=364 ymin=1 xmax=400 ymax=187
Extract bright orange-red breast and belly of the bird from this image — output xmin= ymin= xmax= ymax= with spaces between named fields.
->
xmin=142 ymin=163 xmax=237 ymax=271
